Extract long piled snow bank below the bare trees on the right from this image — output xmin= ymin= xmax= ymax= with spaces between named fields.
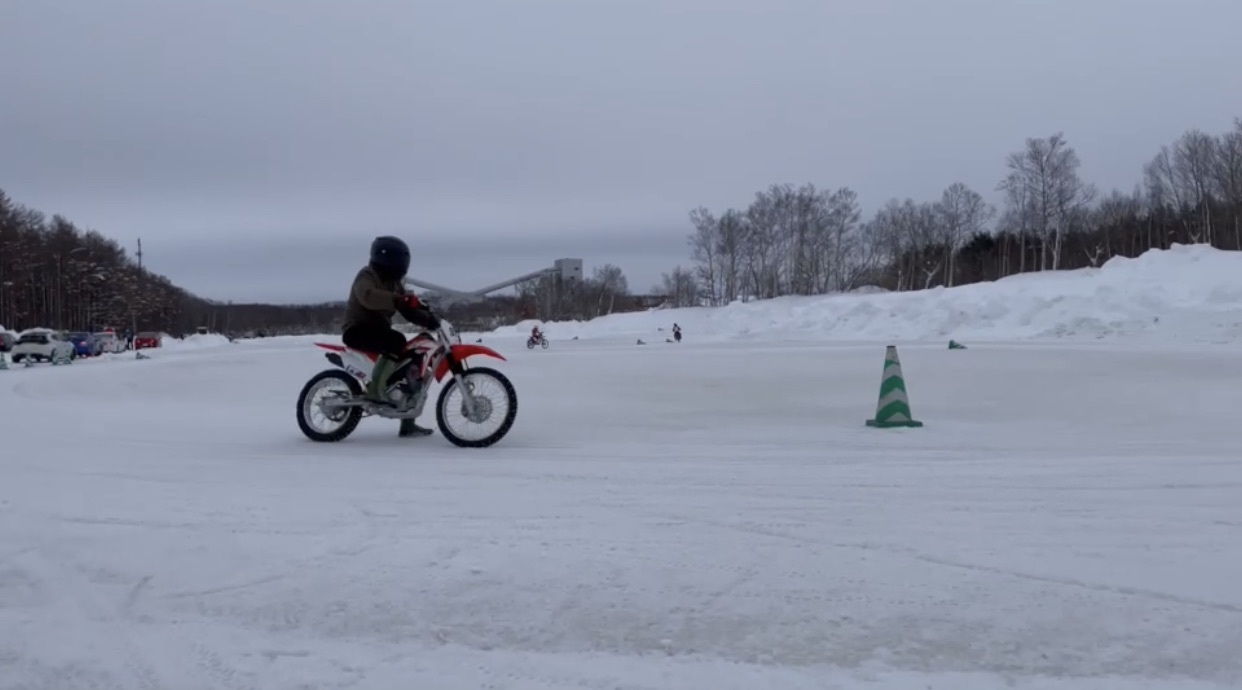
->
xmin=492 ymin=246 xmax=1242 ymax=341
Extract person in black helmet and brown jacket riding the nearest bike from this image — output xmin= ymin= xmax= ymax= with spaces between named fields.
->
xmin=342 ymin=236 xmax=440 ymax=436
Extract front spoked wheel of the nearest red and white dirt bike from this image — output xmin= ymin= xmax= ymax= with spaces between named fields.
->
xmin=436 ymin=366 xmax=518 ymax=448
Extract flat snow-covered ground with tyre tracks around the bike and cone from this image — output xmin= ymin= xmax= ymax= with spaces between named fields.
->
xmin=0 ymin=245 xmax=1242 ymax=690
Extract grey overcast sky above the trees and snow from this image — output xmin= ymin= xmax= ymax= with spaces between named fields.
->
xmin=0 ymin=0 xmax=1242 ymax=302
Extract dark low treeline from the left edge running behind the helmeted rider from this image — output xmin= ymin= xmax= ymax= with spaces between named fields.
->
xmin=0 ymin=183 xmax=652 ymax=336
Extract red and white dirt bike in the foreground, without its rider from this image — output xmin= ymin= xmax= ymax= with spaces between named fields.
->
xmin=298 ymin=321 xmax=518 ymax=448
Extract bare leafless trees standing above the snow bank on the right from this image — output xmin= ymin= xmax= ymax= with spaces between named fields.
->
xmin=662 ymin=118 xmax=1242 ymax=307
